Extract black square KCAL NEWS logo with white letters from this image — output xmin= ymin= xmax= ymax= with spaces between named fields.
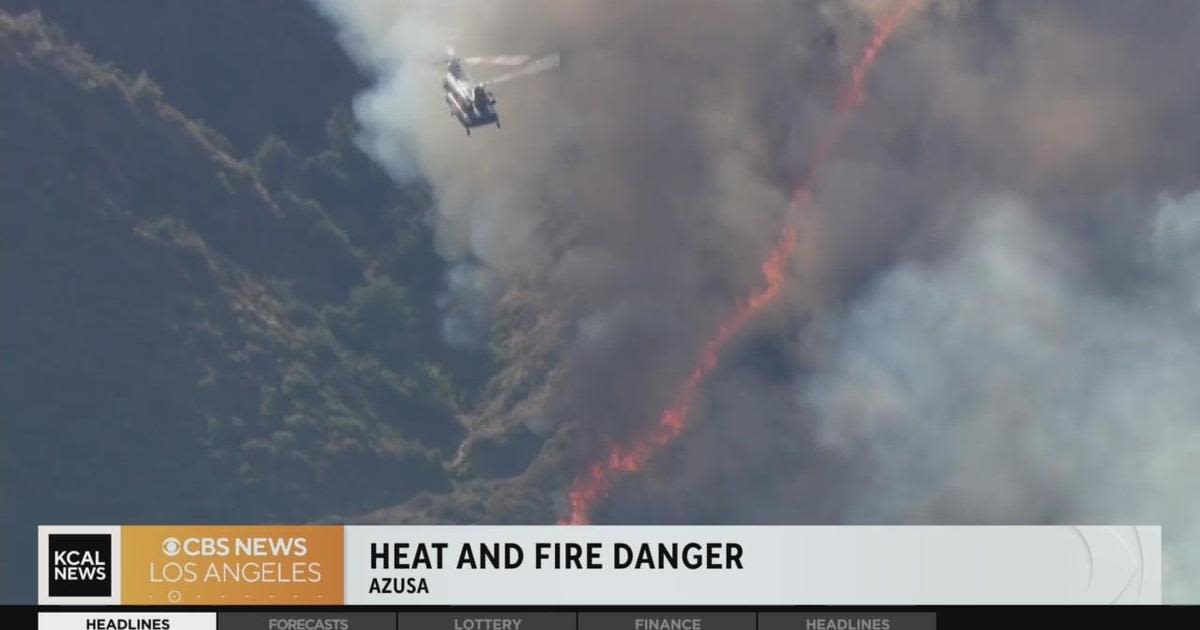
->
xmin=47 ymin=534 xmax=113 ymax=598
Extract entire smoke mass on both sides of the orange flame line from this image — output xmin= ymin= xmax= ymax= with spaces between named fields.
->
xmin=317 ymin=0 xmax=1200 ymax=600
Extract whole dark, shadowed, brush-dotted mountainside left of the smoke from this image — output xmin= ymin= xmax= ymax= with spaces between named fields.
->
xmin=0 ymin=0 xmax=506 ymax=600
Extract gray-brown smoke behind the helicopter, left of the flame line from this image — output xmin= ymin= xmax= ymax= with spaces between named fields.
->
xmin=304 ymin=0 xmax=854 ymax=450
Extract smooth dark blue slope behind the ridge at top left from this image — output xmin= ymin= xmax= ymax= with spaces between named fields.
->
xmin=0 ymin=0 xmax=365 ymax=154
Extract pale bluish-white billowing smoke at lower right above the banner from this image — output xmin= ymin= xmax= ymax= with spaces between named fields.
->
xmin=802 ymin=192 xmax=1200 ymax=600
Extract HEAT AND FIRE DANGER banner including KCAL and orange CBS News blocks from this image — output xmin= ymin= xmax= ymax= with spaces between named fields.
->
xmin=37 ymin=526 xmax=1163 ymax=606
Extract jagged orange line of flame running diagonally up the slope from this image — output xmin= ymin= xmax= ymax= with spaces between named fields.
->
xmin=562 ymin=0 xmax=918 ymax=524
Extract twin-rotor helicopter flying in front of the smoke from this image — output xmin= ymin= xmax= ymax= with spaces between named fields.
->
xmin=442 ymin=49 xmax=560 ymax=136
